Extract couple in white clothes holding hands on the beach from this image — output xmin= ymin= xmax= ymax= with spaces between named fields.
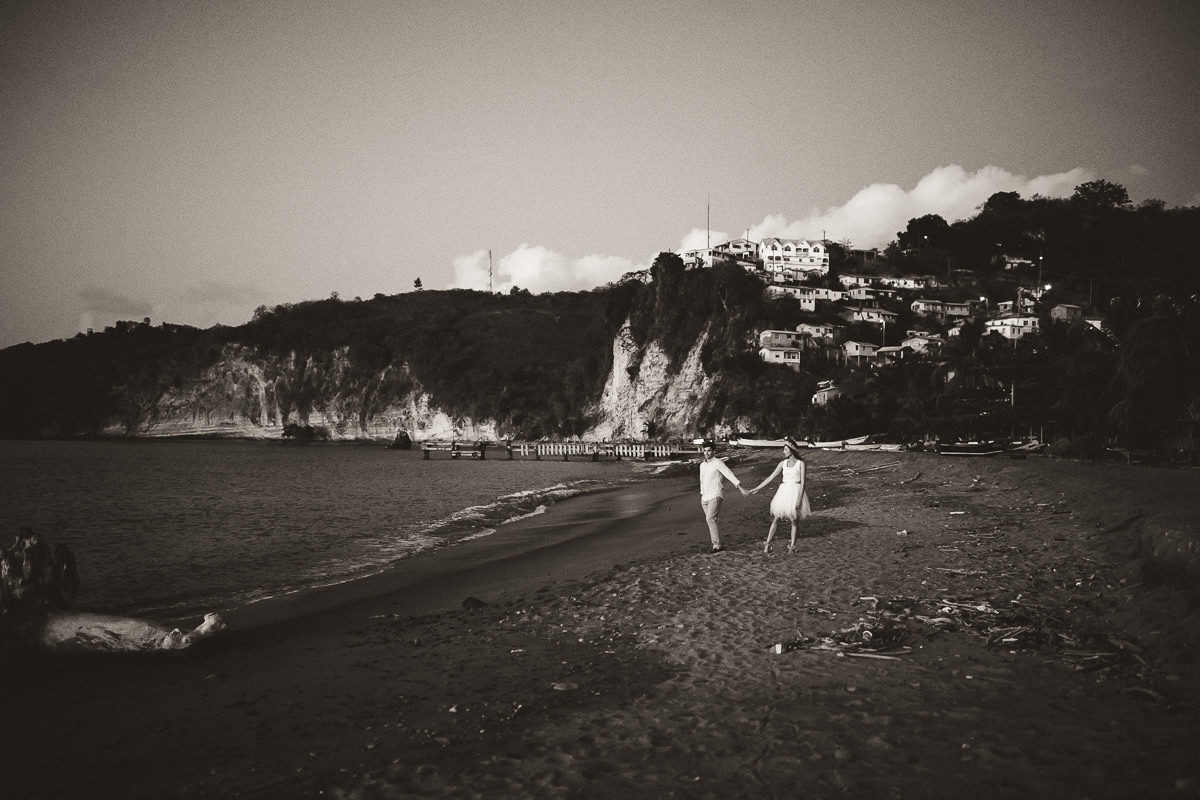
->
xmin=700 ymin=437 xmax=812 ymax=553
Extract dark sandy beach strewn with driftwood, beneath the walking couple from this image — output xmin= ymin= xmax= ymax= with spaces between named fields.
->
xmin=0 ymin=452 xmax=1200 ymax=799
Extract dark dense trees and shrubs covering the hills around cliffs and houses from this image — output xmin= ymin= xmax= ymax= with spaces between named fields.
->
xmin=0 ymin=181 xmax=1200 ymax=452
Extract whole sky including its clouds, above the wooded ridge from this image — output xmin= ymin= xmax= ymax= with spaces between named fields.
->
xmin=0 ymin=0 xmax=1200 ymax=347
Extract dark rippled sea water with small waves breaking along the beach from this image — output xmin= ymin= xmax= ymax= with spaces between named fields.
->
xmin=0 ymin=440 xmax=638 ymax=620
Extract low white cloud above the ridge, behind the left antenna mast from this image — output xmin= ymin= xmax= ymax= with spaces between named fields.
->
xmin=450 ymin=242 xmax=644 ymax=293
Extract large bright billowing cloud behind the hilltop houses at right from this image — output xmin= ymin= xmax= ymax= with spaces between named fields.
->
xmin=750 ymin=164 xmax=1094 ymax=247
